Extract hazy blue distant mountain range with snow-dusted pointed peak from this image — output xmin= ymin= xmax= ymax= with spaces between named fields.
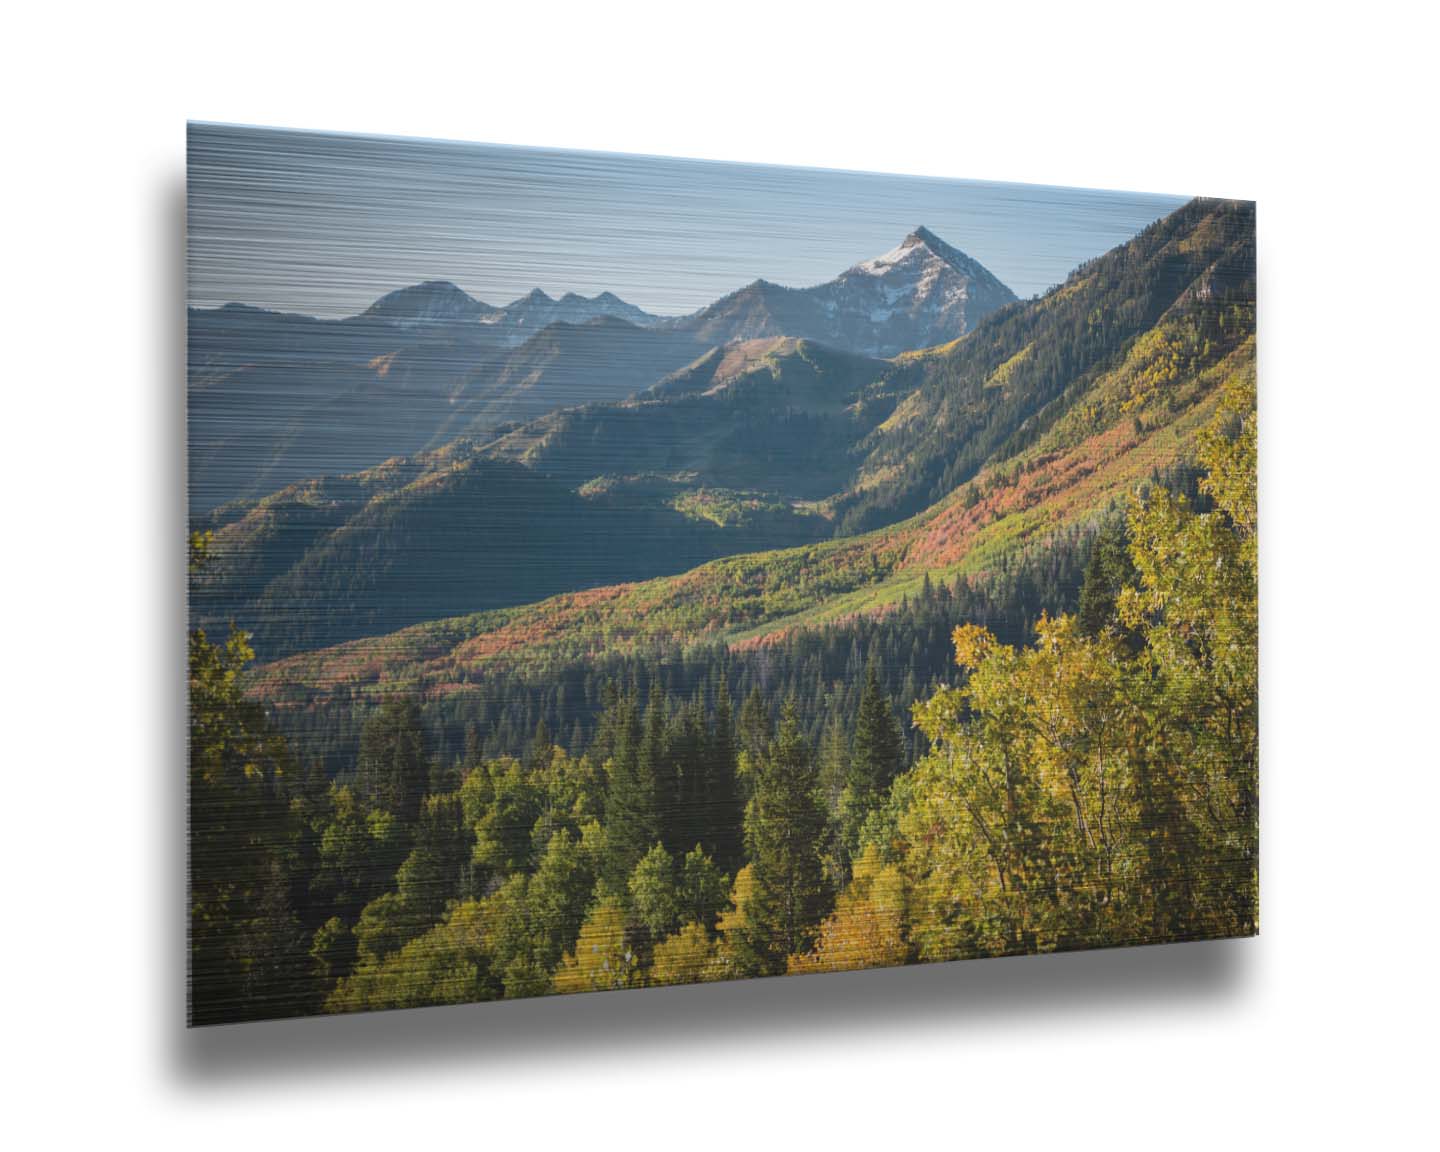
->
xmin=187 ymin=229 xmax=1014 ymax=518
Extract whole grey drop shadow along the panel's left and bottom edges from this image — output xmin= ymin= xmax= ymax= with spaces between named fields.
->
xmin=160 ymin=173 xmax=1253 ymax=1089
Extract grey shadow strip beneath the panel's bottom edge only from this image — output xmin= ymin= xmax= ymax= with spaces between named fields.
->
xmin=171 ymin=940 xmax=1248 ymax=1087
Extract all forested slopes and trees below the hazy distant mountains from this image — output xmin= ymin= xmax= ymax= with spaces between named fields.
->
xmin=190 ymin=202 xmax=1257 ymax=1022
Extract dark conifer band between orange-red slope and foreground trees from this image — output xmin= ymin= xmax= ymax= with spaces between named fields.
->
xmin=274 ymin=515 xmax=1100 ymax=776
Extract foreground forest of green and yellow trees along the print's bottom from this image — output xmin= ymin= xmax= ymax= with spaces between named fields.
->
xmin=190 ymin=364 xmax=1257 ymax=1022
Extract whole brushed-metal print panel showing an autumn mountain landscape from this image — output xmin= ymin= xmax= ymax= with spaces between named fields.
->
xmin=187 ymin=125 xmax=1257 ymax=1024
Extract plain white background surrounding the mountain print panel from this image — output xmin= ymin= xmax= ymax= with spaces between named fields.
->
xmin=0 ymin=0 xmax=1440 ymax=1149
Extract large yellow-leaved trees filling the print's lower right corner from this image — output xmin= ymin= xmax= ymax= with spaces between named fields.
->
xmin=904 ymin=376 xmax=1257 ymax=959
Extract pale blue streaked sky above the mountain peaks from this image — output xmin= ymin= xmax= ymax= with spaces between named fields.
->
xmin=187 ymin=124 xmax=1185 ymax=315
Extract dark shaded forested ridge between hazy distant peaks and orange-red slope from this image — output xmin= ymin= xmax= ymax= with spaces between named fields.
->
xmin=194 ymin=202 xmax=1254 ymax=660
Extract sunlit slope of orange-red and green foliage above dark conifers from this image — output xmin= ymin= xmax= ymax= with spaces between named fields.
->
xmin=253 ymin=326 xmax=1254 ymax=707
